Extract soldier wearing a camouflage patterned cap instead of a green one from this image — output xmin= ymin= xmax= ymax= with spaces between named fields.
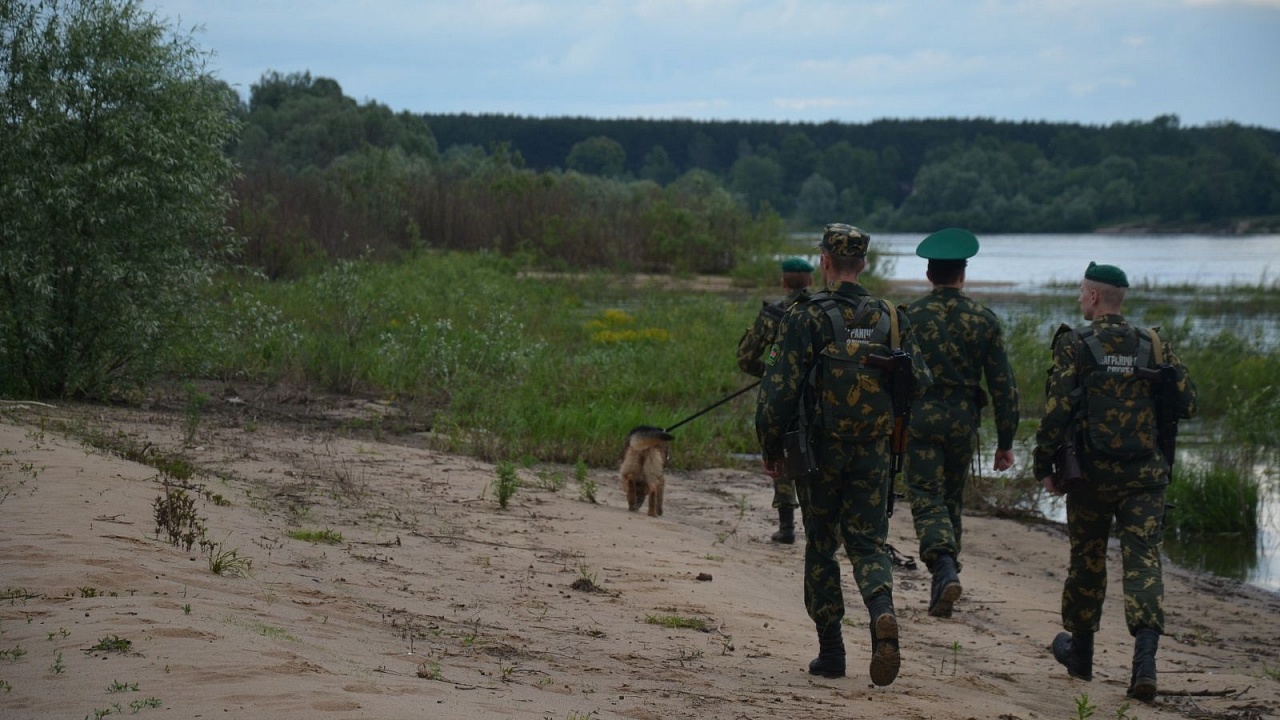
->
xmin=755 ymin=223 xmax=929 ymax=685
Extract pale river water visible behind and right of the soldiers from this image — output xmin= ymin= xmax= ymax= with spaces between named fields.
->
xmin=796 ymin=233 xmax=1280 ymax=592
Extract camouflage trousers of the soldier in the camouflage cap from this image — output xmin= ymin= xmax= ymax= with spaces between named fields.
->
xmin=796 ymin=430 xmax=893 ymax=628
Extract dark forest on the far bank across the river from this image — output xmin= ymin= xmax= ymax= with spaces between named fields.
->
xmin=426 ymin=114 xmax=1280 ymax=232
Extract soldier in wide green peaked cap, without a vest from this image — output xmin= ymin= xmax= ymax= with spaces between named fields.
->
xmin=906 ymin=228 xmax=1018 ymax=618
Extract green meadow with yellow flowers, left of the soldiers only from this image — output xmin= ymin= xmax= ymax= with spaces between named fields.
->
xmin=173 ymin=254 xmax=760 ymax=466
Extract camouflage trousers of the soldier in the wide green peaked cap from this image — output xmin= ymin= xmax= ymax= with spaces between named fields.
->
xmin=904 ymin=423 xmax=977 ymax=569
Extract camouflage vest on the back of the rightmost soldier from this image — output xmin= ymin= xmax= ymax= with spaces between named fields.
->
xmin=1071 ymin=327 xmax=1164 ymax=460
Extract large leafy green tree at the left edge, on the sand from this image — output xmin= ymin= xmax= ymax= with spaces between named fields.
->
xmin=0 ymin=0 xmax=237 ymax=397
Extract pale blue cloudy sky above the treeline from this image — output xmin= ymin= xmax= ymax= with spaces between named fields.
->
xmin=142 ymin=0 xmax=1280 ymax=129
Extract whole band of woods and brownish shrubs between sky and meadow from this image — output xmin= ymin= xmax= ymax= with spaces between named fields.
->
xmin=229 ymin=73 xmax=1280 ymax=277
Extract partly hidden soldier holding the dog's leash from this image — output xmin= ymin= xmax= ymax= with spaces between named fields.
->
xmin=737 ymin=258 xmax=813 ymax=544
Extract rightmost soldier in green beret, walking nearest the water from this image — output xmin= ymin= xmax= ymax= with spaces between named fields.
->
xmin=1036 ymin=263 xmax=1197 ymax=702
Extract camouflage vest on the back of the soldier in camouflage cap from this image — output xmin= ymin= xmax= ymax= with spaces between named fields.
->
xmin=809 ymin=292 xmax=900 ymax=442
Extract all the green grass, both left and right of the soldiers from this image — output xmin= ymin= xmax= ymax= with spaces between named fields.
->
xmin=170 ymin=251 xmax=1280 ymax=525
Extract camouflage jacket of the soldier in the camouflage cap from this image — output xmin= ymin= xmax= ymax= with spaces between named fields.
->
xmin=755 ymin=282 xmax=931 ymax=461
